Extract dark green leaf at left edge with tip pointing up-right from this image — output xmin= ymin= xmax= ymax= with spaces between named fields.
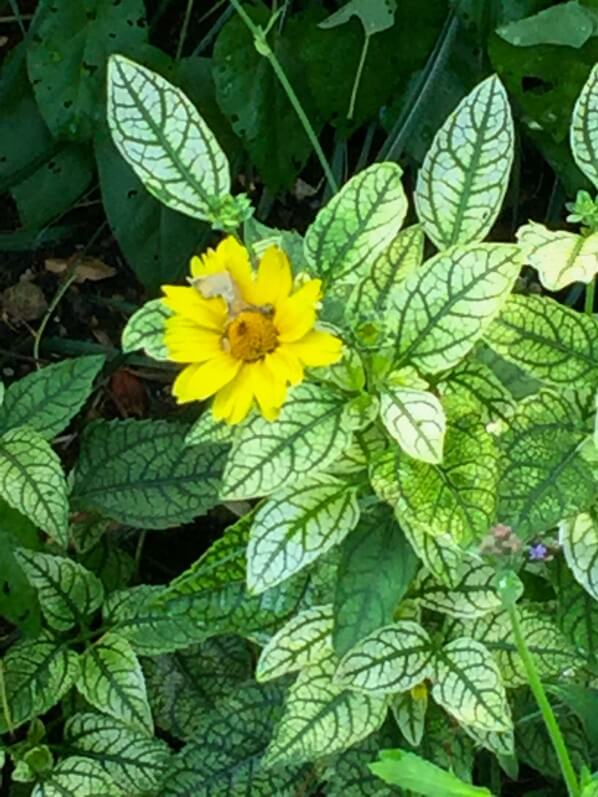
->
xmin=0 ymin=355 xmax=104 ymax=440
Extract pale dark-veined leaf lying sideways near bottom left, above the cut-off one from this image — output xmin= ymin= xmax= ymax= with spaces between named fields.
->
xmin=64 ymin=713 xmax=171 ymax=794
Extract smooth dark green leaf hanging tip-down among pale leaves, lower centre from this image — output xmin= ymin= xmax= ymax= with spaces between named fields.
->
xmin=333 ymin=504 xmax=417 ymax=656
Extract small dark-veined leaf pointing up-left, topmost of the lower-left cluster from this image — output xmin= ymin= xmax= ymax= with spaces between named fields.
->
xmin=16 ymin=548 xmax=104 ymax=631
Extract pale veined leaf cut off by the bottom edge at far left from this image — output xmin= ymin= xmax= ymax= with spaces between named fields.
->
xmin=31 ymin=756 xmax=123 ymax=797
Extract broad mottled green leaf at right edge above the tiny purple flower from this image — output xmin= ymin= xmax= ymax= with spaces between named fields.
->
xmin=498 ymin=390 xmax=596 ymax=539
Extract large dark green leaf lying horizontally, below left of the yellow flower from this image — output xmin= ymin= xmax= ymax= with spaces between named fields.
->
xmin=73 ymin=420 xmax=225 ymax=529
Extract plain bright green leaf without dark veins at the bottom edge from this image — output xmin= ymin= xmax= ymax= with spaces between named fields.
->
xmin=370 ymin=749 xmax=492 ymax=797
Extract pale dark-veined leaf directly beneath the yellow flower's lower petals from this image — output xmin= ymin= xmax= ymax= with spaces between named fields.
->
xmin=221 ymin=383 xmax=351 ymax=500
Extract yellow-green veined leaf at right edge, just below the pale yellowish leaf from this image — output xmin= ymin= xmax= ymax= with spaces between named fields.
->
xmin=486 ymin=296 xmax=598 ymax=387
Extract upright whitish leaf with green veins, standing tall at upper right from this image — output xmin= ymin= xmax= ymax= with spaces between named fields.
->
xmin=415 ymin=75 xmax=513 ymax=249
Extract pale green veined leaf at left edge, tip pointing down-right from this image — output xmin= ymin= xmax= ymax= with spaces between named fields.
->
xmin=0 ymin=426 xmax=68 ymax=545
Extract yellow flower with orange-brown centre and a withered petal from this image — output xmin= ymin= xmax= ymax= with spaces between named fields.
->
xmin=162 ymin=237 xmax=342 ymax=424
